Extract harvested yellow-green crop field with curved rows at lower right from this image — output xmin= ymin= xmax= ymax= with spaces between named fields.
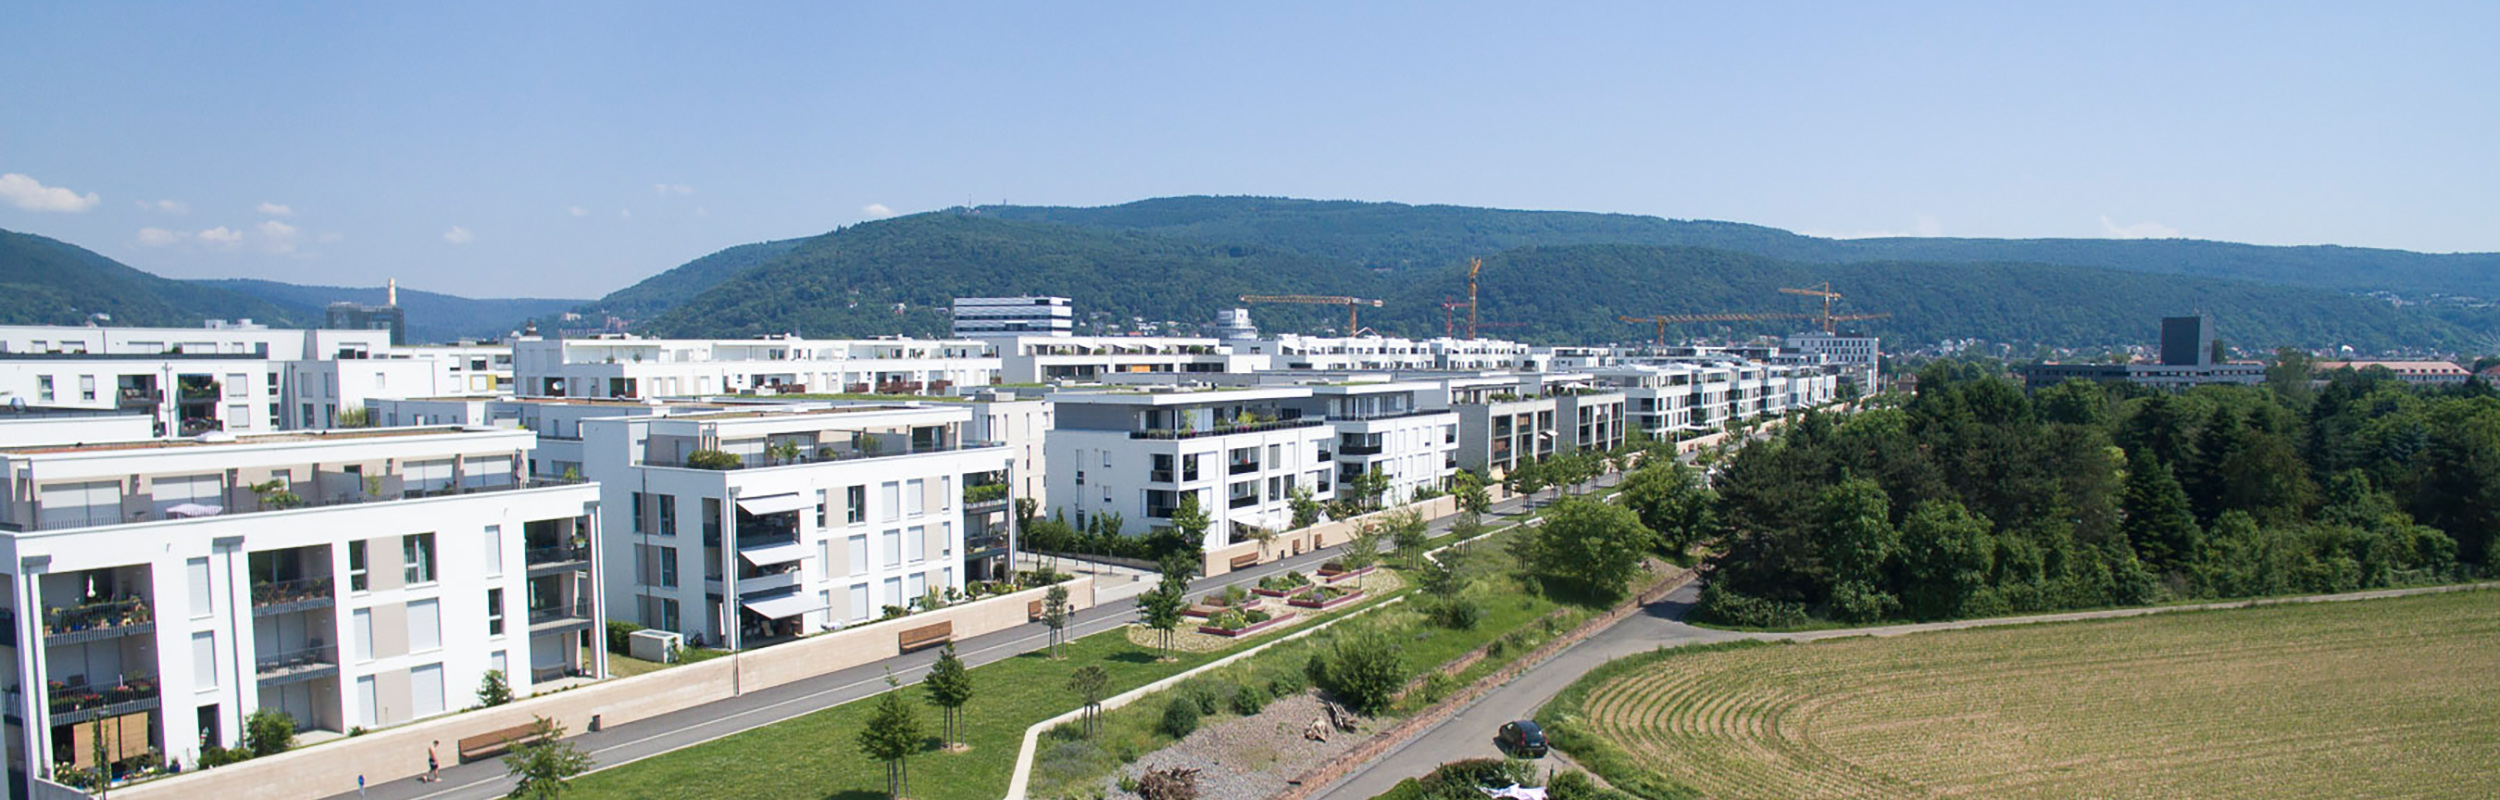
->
xmin=1540 ymin=590 xmax=2500 ymax=798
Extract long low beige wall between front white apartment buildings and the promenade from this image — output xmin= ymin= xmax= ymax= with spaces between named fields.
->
xmin=113 ymin=578 xmax=1093 ymax=800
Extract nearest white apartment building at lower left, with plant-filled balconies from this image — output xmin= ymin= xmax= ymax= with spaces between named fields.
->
xmin=0 ymin=428 xmax=605 ymax=778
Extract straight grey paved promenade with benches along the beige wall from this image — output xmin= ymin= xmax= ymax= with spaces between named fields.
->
xmin=330 ymin=475 xmax=1618 ymax=800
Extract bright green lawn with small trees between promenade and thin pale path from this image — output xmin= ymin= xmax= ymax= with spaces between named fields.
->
xmin=565 ymin=633 xmax=1218 ymax=800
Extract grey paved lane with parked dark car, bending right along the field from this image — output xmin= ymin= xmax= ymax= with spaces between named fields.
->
xmin=1313 ymin=583 xmax=2500 ymax=800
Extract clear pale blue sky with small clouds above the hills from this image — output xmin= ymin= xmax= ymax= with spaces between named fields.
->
xmin=0 ymin=3 xmax=2500 ymax=298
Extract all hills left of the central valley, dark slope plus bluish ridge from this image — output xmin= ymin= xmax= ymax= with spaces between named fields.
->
xmin=0 ymin=230 xmax=583 ymax=343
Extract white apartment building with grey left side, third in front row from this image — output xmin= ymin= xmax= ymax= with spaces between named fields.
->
xmin=1045 ymin=388 xmax=1338 ymax=548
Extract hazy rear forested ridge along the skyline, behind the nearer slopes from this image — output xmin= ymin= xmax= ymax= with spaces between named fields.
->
xmin=980 ymin=198 xmax=2500 ymax=298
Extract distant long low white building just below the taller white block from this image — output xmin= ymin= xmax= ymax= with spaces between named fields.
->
xmin=990 ymin=335 xmax=1268 ymax=385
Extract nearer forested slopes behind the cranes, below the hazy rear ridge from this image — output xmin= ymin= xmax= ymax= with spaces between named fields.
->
xmin=638 ymin=213 xmax=2488 ymax=350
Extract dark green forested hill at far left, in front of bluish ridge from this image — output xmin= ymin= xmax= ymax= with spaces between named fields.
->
xmin=0 ymin=230 xmax=300 ymax=328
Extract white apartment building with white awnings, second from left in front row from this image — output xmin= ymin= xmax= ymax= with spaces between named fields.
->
xmin=580 ymin=403 xmax=1013 ymax=648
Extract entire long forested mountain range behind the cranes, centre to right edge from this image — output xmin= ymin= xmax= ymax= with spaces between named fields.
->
xmin=572 ymin=198 xmax=2500 ymax=350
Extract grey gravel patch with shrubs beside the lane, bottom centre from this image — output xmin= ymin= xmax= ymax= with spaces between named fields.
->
xmin=1103 ymin=693 xmax=1380 ymax=800
